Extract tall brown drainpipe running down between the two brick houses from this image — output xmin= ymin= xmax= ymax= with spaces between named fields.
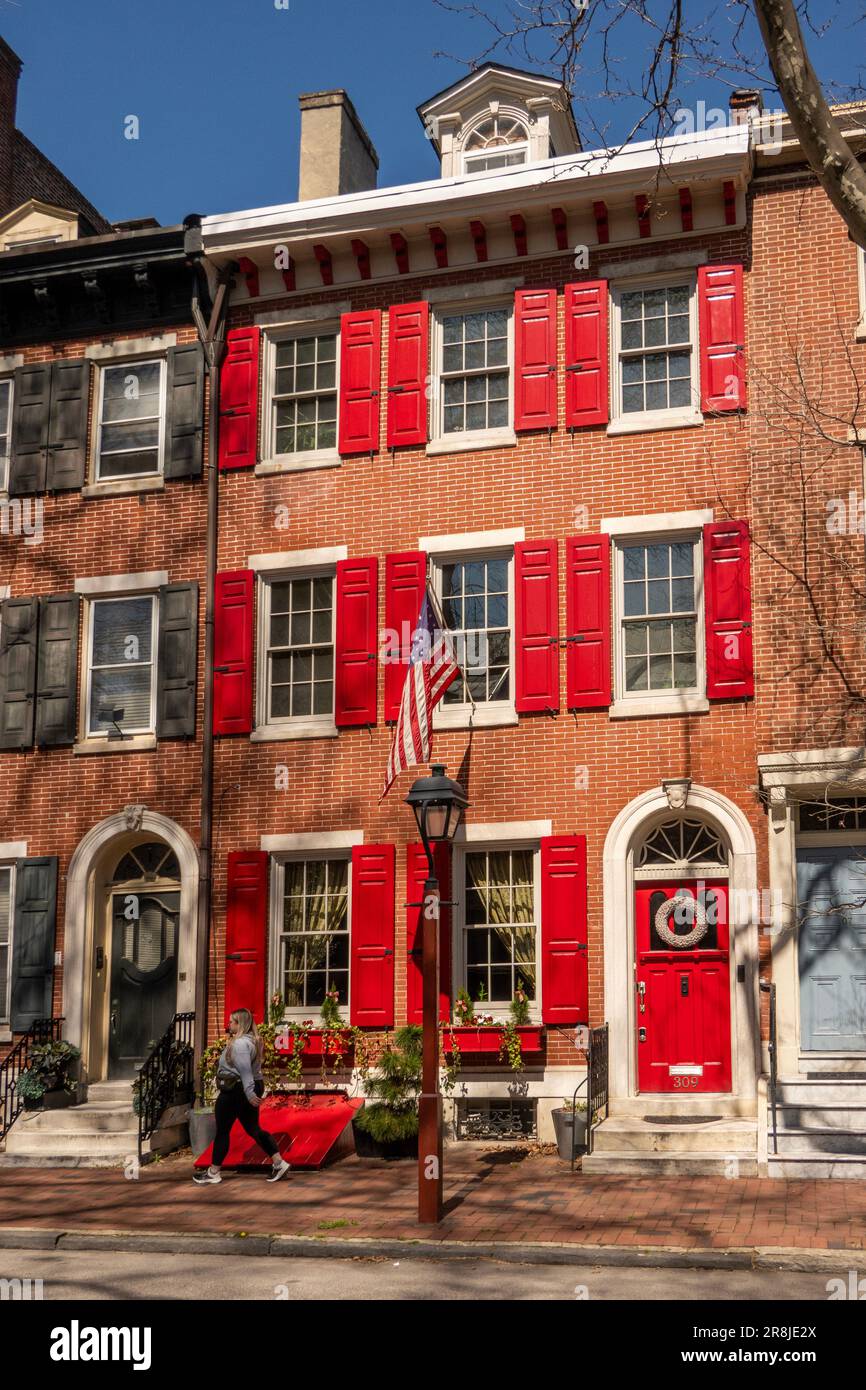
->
xmin=183 ymin=213 xmax=236 ymax=1081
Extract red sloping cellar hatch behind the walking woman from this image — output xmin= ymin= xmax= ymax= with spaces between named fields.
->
xmin=196 ymin=1094 xmax=364 ymax=1168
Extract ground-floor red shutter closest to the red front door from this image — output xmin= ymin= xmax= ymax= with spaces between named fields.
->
xmin=541 ymin=835 xmax=589 ymax=1023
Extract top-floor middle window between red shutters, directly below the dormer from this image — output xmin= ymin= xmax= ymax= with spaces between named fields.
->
xmin=432 ymin=304 xmax=513 ymax=448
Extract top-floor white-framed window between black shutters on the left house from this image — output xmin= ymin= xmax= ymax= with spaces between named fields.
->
xmin=96 ymin=357 xmax=165 ymax=482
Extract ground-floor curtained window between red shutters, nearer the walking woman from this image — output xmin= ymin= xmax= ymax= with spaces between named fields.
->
xmin=274 ymin=855 xmax=350 ymax=1017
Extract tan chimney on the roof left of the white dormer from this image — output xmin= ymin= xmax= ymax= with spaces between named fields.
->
xmin=297 ymin=92 xmax=379 ymax=203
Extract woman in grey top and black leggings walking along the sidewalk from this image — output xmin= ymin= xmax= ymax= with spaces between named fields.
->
xmin=192 ymin=1009 xmax=291 ymax=1187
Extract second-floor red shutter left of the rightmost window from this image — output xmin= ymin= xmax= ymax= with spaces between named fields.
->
xmin=566 ymin=535 xmax=610 ymax=709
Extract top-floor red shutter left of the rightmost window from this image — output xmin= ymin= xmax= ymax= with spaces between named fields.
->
xmin=566 ymin=279 xmax=610 ymax=430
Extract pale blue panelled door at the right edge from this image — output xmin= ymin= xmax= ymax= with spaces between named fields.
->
xmin=796 ymin=847 xmax=866 ymax=1052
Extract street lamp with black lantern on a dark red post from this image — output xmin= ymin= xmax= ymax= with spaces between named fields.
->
xmin=406 ymin=765 xmax=468 ymax=1225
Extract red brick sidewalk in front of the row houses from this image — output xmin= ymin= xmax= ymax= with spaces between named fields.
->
xmin=0 ymin=1145 xmax=866 ymax=1250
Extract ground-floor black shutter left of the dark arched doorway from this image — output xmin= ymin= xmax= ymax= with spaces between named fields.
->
xmin=11 ymin=856 xmax=57 ymax=1033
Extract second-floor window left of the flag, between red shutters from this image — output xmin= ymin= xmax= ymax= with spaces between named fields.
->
xmin=259 ymin=570 xmax=335 ymax=733
